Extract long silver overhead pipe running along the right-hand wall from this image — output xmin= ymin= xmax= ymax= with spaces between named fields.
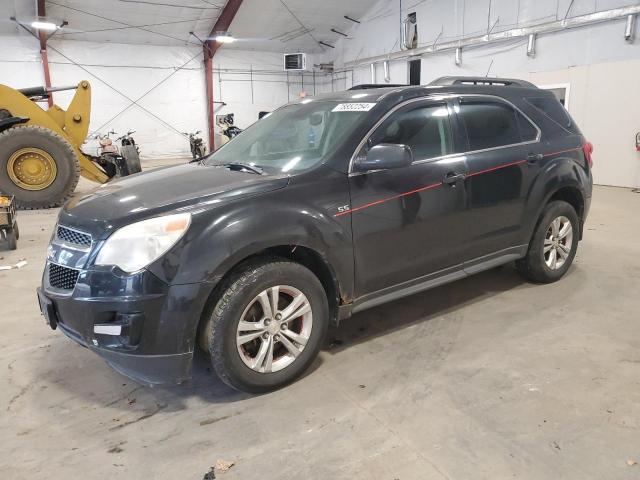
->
xmin=344 ymin=5 xmax=640 ymax=69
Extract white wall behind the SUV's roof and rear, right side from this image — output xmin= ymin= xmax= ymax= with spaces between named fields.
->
xmin=335 ymin=0 xmax=640 ymax=187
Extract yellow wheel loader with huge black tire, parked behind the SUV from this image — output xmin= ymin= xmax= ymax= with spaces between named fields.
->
xmin=0 ymin=80 xmax=140 ymax=209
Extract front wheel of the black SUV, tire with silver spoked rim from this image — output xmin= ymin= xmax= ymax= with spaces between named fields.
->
xmin=199 ymin=257 xmax=329 ymax=393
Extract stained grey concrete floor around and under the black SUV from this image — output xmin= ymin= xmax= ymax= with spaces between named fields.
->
xmin=0 ymin=183 xmax=640 ymax=480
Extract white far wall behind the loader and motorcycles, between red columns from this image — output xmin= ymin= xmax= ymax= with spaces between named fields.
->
xmin=0 ymin=36 xmax=338 ymax=160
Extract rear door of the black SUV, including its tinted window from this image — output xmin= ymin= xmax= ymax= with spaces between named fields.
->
xmin=455 ymin=95 xmax=542 ymax=261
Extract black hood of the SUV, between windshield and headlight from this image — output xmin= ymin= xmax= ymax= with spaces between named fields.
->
xmin=60 ymin=163 xmax=289 ymax=233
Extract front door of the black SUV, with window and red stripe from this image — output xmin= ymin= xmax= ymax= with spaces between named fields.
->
xmin=349 ymin=100 xmax=467 ymax=297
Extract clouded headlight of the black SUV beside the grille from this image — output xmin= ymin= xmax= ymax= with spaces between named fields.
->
xmin=96 ymin=213 xmax=191 ymax=272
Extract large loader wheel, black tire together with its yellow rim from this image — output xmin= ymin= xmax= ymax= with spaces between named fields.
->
xmin=0 ymin=125 xmax=80 ymax=209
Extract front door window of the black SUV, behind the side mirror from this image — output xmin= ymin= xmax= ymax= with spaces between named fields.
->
xmin=367 ymin=104 xmax=453 ymax=160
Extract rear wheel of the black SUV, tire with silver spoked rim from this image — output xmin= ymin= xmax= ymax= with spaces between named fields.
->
xmin=516 ymin=200 xmax=580 ymax=283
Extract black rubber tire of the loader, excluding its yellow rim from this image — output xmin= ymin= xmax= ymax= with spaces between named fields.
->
xmin=0 ymin=125 xmax=80 ymax=209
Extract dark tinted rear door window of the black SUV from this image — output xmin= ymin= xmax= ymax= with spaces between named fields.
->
xmin=458 ymin=101 xmax=522 ymax=150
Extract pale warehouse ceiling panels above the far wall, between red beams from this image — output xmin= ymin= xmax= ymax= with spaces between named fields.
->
xmin=5 ymin=0 xmax=371 ymax=53
